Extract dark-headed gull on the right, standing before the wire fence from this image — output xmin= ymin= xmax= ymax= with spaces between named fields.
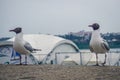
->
xmin=89 ymin=23 xmax=110 ymax=66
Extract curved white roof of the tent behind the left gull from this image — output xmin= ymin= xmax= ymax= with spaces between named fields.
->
xmin=8 ymin=34 xmax=79 ymax=54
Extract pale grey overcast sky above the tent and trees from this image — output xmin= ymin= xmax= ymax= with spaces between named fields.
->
xmin=0 ymin=0 xmax=120 ymax=37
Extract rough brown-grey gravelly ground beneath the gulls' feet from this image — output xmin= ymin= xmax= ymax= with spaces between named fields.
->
xmin=0 ymin=65 xmax=120 ymax=80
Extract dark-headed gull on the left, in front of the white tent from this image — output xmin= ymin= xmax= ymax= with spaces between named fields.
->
xmin=10 ymin=27 xmax=41 ymax=65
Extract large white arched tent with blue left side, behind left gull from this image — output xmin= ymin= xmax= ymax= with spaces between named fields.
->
xmin=0 ymin=34 xmax=79 ymax=64
